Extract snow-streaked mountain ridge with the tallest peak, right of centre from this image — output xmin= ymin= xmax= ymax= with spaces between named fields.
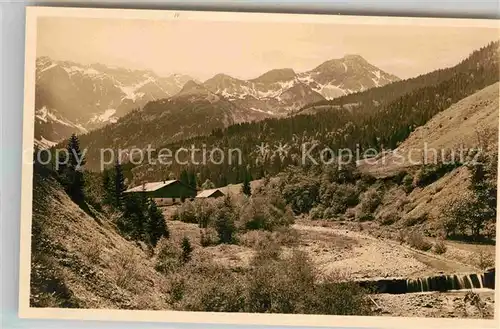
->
xmin=203 ymin=55 xmax=400 ymax=115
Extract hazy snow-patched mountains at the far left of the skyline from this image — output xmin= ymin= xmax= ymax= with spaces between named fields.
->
xmin=35 ymin=57 xmax=193 ymax=147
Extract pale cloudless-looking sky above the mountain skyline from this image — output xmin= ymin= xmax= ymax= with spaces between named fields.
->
xmin=37 ymin=17 xmax=498 ymax=81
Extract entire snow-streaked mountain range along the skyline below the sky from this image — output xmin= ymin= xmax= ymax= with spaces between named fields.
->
xmin=35 ymin=55 xmax=399 ymax=147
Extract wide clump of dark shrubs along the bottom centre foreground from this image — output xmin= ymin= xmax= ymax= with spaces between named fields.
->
xmin=166 ymin=241 xmax=371 ymax=315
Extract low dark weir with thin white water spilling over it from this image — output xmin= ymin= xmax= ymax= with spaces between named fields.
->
xmin=357 ymin=268 xmax=495 ymax=294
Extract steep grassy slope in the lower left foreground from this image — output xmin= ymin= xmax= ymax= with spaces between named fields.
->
xmin=30 ymin=167 xmax=167 ymax=309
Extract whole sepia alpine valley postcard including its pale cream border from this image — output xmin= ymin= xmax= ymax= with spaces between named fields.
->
xmin=19 ymin=7 xmax=500 ymax=328
